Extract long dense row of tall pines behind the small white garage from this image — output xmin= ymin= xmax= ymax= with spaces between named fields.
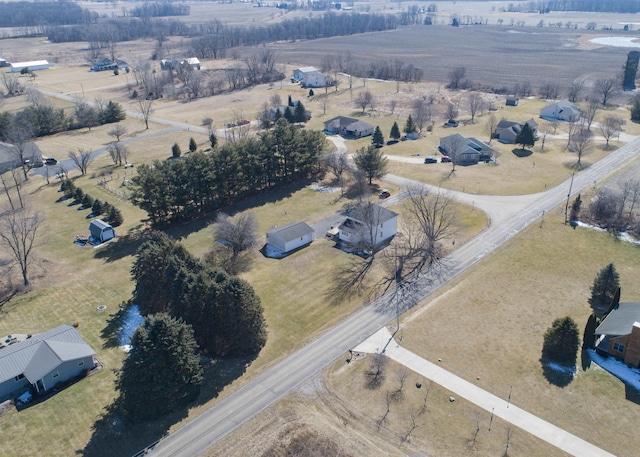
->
xmin=132 ymin=119 xmax=326 ymax=224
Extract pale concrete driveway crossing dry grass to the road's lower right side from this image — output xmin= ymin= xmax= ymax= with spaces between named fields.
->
xmin=353 ymin=327 xmax=614 ymax=457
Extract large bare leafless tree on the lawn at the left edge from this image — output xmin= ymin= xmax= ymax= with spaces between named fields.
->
xmin=0 ymin=209 xmax=43 ymax=286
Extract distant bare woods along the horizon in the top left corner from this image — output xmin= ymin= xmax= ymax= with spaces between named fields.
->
xmin=0 ymin=2 xmax=98 ymax=27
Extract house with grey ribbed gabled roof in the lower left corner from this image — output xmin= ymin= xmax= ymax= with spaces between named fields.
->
xmin=0 ymin=324 xmax=96 ymax=400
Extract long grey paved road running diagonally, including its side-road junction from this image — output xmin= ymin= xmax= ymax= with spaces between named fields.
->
xmin=148 ymin=134 xmax=640 ymax=457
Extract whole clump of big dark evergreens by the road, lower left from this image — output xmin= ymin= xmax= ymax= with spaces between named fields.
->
xmin=117 ymin=232 xmax=267 ymax=422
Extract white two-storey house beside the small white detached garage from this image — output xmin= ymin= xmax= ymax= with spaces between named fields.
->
xmin=338 ymin=203 xmax=398 ymax=246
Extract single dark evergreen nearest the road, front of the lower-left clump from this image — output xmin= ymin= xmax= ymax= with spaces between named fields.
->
xmin=117 ymin=313 xmax=204 ymax=422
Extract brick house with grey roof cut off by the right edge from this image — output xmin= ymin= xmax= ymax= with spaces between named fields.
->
xmin=595 ymin=302 xmax=640 ymax=367
